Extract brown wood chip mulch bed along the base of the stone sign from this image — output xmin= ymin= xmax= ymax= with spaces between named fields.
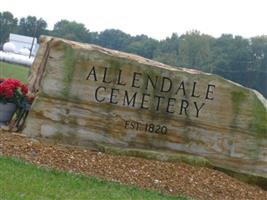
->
xmin=0 ymin=131 xmax=267 ymax=200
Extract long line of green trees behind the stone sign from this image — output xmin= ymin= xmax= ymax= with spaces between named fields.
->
xmin=0 ymin=12 xmax=267 ymax=97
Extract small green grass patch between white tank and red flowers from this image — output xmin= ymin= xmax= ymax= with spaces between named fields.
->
xmin=0 ymin=62 xmax=30 ymax=83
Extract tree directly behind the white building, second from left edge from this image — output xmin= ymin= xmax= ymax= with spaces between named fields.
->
xmin=18 ymin=16 xmax=47 ymax=38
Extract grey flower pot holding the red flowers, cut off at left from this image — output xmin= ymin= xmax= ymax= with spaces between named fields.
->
xmin=0 ymin=103 xmax=16 ymax=127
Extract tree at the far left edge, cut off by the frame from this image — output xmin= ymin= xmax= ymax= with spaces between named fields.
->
xmin=0 ymin=12 xmax=18 ymax=45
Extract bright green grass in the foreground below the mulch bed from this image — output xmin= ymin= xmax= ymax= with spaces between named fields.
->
xmin=0 ymin=157 xmax=187 ymax=200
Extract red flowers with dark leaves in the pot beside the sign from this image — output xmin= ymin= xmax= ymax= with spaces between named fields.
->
xmin=0 ymin=78 xmax=31 ymax=108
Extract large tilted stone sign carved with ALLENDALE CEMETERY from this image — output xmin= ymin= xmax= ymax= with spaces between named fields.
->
xmin=24 ymin=37 xmax=267 ymax=182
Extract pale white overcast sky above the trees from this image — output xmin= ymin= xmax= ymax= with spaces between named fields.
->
xmin=0 ymin=0 xmax=267 ymax=40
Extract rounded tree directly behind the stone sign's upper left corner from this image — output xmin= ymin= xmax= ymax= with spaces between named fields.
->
xmin=51 ymin=20 xmax=90 ymax=42
